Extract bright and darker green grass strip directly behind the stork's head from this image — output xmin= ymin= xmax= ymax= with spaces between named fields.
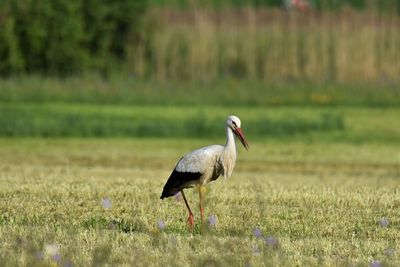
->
xmin=0 ymin=103 xmax=400 ymax=143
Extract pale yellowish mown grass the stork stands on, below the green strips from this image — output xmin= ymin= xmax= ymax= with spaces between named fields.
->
xmin=0 ymin=139 xmax=400 ymax=266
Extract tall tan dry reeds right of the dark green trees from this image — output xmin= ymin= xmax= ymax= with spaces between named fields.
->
xmin=131 ymin=8 xmax=400 ymax=82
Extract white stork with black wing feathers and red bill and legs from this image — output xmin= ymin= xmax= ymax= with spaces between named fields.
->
xmin=160 ymin=115 xmax=249 ymax=229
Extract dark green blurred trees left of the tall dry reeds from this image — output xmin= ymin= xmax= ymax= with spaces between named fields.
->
xmin=0 ymin=0 xmax=146 ymax=76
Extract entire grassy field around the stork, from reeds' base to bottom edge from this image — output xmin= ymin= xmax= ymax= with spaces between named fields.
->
xmin=0 ymin=76 xmax=400 ymax=266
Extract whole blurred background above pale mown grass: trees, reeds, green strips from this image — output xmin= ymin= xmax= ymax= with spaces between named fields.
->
xmin=0 ymin=0 xmax=400 ymax=143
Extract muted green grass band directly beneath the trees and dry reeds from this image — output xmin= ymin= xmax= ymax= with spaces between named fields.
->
xmin=0 ymin=74 xmax=400 ymax=107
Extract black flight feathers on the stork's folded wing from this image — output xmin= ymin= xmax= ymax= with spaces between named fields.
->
xmin=160 ymin=170 xmax=202 ymax=199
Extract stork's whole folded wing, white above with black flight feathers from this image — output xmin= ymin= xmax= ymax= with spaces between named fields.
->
xmin=161 ymin=145 xmax=223 ymax=199
